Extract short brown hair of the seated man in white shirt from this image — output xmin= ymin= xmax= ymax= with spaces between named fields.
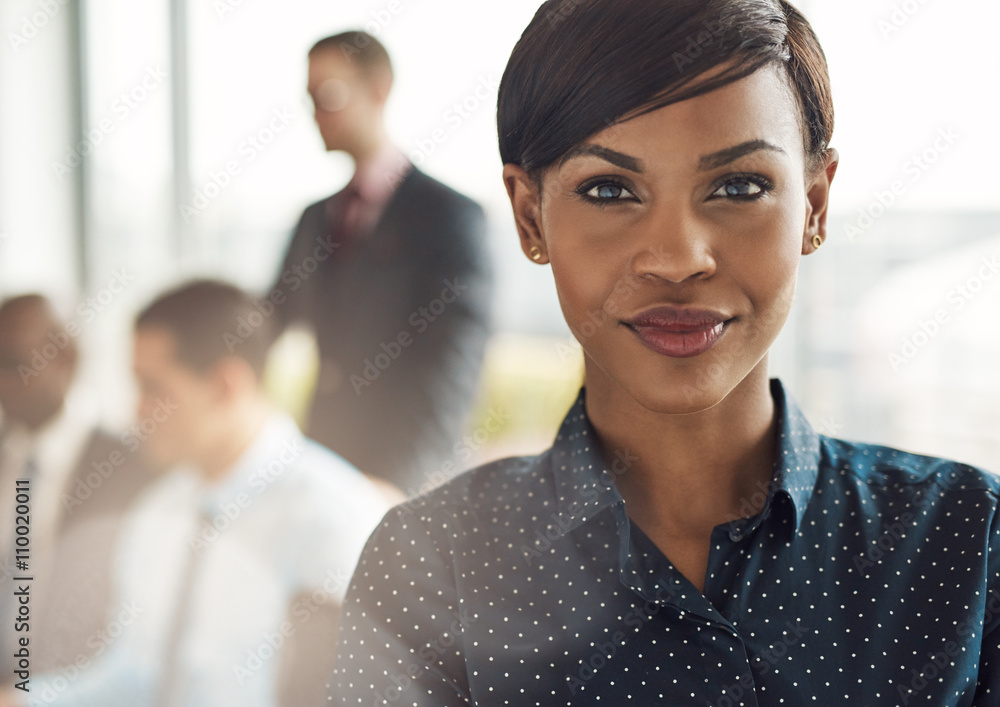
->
xmin=135 ymin=280 xmax=278 ymax=378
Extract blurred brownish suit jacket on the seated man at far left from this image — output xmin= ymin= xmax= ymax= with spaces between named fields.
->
xmin=6 ymin=431 xmax=154 ymax=671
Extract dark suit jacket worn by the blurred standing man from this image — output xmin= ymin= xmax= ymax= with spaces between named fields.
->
xmin=274 ymin=167 xmax=493 ymax=491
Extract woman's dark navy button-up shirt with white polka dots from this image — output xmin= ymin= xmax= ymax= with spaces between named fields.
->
xmin=329 ymin=380 xmax=1000 ymax=707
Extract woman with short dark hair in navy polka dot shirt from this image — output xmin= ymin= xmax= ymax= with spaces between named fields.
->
xmin=331 ymin=0 xmax=1000 ymax=706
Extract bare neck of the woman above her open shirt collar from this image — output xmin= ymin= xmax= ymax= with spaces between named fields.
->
xmin=586 ymin=358 xmax=777 ymax=541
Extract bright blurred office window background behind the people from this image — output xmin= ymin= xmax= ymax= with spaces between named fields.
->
xmin=0 ymin=0 xmax=1000 ymax=471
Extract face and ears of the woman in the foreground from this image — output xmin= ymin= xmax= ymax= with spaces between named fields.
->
xmin=504 ymin=68 xmax=836 ymax=413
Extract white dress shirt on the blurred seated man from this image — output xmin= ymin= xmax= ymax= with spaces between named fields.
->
xmin=29 ymin=413 xmax=388 ymax=707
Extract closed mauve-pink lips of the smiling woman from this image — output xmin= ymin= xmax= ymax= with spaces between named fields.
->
xmin=623 ymin=307 xmax=732 ymax=358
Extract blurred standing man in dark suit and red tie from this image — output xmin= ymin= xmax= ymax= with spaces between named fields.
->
xmin=275 ymin=32 xmax=493 ymax=493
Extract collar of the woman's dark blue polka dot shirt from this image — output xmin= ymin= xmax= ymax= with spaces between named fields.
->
xmin=549 ymin=378 xmax=820 ymax=535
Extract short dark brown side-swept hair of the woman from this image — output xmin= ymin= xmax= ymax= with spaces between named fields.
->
xmin=497 ymin=0 xmax=833 ymax=179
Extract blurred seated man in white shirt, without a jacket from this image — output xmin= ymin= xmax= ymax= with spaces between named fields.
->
xmin=0 ymin=281 xmax=387 ymax=707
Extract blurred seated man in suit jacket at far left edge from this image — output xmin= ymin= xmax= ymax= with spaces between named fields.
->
xmin=0 ymin=295 xmax=150 ymax=683
